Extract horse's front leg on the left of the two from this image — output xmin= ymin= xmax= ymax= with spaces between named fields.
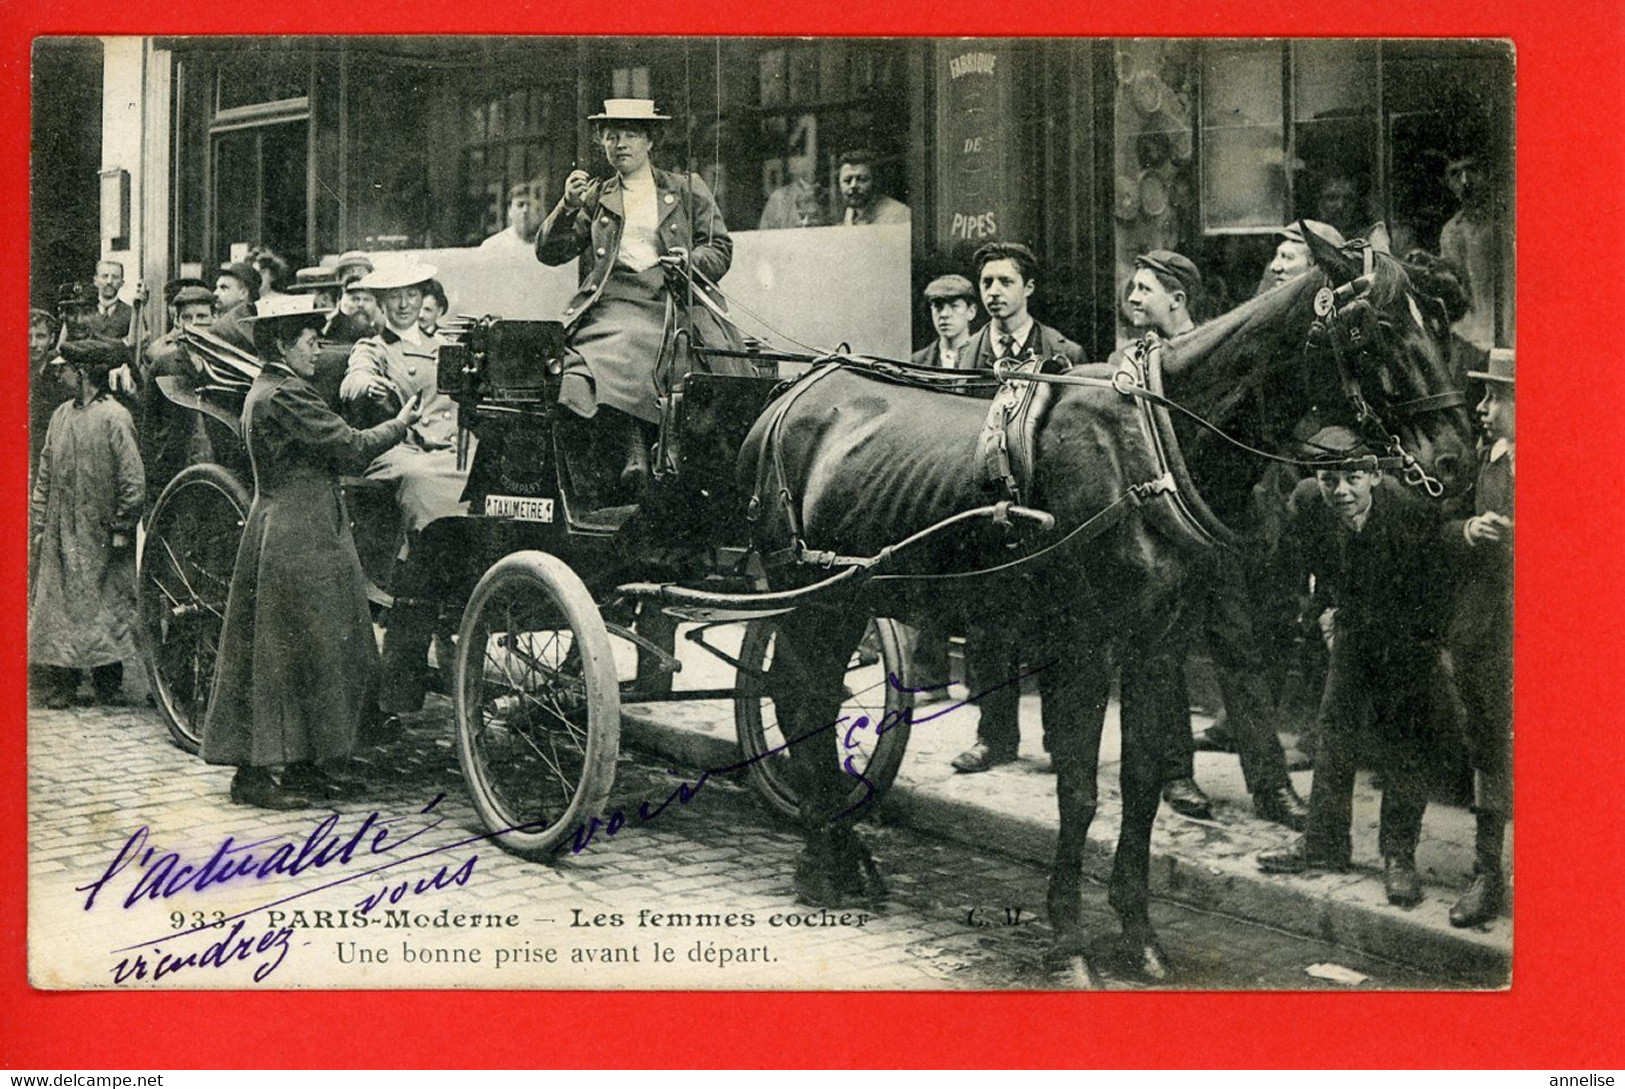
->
xmin=1038 ymin=639 xmax=1110 ymax=988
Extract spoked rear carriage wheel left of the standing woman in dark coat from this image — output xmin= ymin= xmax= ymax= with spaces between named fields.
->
xmin=137 ymin=465 xmax=249 ymax=753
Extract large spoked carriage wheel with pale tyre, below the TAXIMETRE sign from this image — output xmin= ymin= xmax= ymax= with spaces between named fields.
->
xmin=455 ymin=551 xmax=621 ymax=858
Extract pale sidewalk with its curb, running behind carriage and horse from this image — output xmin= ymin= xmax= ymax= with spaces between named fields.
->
xmin=622 ymin=629 xmax=1511 ymax=987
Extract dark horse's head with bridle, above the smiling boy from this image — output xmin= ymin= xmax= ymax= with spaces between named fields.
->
xmin=1300 ymin=224 xmax=1474 ymax=497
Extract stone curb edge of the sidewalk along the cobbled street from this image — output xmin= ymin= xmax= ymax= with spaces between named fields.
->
xmin=621 ymin=705 xmax=1511 ymax=988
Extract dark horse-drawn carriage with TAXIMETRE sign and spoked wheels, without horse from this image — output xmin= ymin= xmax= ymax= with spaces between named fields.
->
xmin=138 ymin=317 xmax=942 ymax=858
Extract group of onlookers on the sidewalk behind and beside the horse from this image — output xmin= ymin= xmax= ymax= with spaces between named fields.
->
xmin=913 ymin=149 xmax=1516 ymax=926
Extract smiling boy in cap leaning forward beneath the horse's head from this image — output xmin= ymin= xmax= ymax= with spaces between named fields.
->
xmin=1258 ymin=426 xmax=1451 ymax=907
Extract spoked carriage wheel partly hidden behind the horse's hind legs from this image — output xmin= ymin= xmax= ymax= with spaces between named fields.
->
xmin=733 ymin=619 xmax=915 ymax=818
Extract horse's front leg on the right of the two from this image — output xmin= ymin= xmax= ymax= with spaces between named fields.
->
xmin=1107 ymin=639 xmax=1186 ymax=982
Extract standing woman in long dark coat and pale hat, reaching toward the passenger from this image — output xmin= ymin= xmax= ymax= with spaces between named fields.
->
xmin=202 ymin=296 xmax=421 ymax=809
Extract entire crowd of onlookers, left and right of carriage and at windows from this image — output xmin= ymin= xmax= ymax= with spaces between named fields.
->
xmin=29 ymin=133 xmax=1515 ymax=925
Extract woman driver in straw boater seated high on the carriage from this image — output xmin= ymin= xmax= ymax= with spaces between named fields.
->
xmin=536 ymin=99 xmax=733 ymax=492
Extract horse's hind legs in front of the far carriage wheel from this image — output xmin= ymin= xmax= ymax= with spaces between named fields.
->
xmin=769 ymin=608 xmax=879 ymax=907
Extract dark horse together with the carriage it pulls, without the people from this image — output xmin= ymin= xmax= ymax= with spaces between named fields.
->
xmin=140 ymin=226 xmax=1472 ymax=987
